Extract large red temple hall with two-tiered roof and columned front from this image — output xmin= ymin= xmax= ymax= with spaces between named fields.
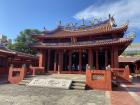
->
xmin=32 ymin=16 xmax=133 ymax=73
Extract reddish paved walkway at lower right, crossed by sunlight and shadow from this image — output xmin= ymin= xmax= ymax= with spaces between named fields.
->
xmin=110 ymin=77 xmax=140 ymax=105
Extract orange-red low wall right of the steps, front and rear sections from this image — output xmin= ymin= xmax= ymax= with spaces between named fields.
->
xmin=86 ymin=66 xmax=131 ymax=90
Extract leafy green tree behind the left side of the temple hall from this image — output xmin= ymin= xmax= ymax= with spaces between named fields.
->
xmin=7 ymin=29 xmax=41 ymax=54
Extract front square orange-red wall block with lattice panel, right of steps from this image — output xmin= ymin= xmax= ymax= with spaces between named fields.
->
xmin=86 ymin=70 xmax=112 ymax=90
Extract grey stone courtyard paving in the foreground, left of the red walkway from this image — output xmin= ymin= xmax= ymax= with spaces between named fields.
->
xmin=0 ymin=84 xmax=108 ymax=105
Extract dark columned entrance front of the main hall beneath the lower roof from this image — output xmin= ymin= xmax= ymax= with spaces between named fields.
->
xmin=45 ymin=49 xmax=114 ymax=73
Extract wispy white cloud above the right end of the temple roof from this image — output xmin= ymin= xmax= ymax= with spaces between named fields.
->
xmin=74 ymin=0 xmax=140 ymax=29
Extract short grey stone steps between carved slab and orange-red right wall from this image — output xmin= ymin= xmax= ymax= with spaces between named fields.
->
xmin=70 ymin=80 xmax=86 ymax=90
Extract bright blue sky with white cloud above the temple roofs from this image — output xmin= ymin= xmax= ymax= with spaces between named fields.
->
xmin=0 ymin=0 xmax=140 ymax=42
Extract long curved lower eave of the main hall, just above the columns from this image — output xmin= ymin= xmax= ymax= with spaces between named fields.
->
xmin=32 ymin=38 xmax=133 ymax=50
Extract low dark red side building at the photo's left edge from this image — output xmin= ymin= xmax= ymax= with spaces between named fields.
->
xmin=0 ymin=44 xmax=38 ymax=75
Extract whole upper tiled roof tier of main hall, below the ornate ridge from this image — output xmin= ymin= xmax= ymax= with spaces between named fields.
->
xmin=33 ymin=21 xmax=128 ymax=39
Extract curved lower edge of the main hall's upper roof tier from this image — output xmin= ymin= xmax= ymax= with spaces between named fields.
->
xmin=33 ymin=24 xmax=128 ymax=39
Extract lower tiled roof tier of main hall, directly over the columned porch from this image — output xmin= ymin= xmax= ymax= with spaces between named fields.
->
xmin=32 ymin=38 xmax=133 ymax=48
